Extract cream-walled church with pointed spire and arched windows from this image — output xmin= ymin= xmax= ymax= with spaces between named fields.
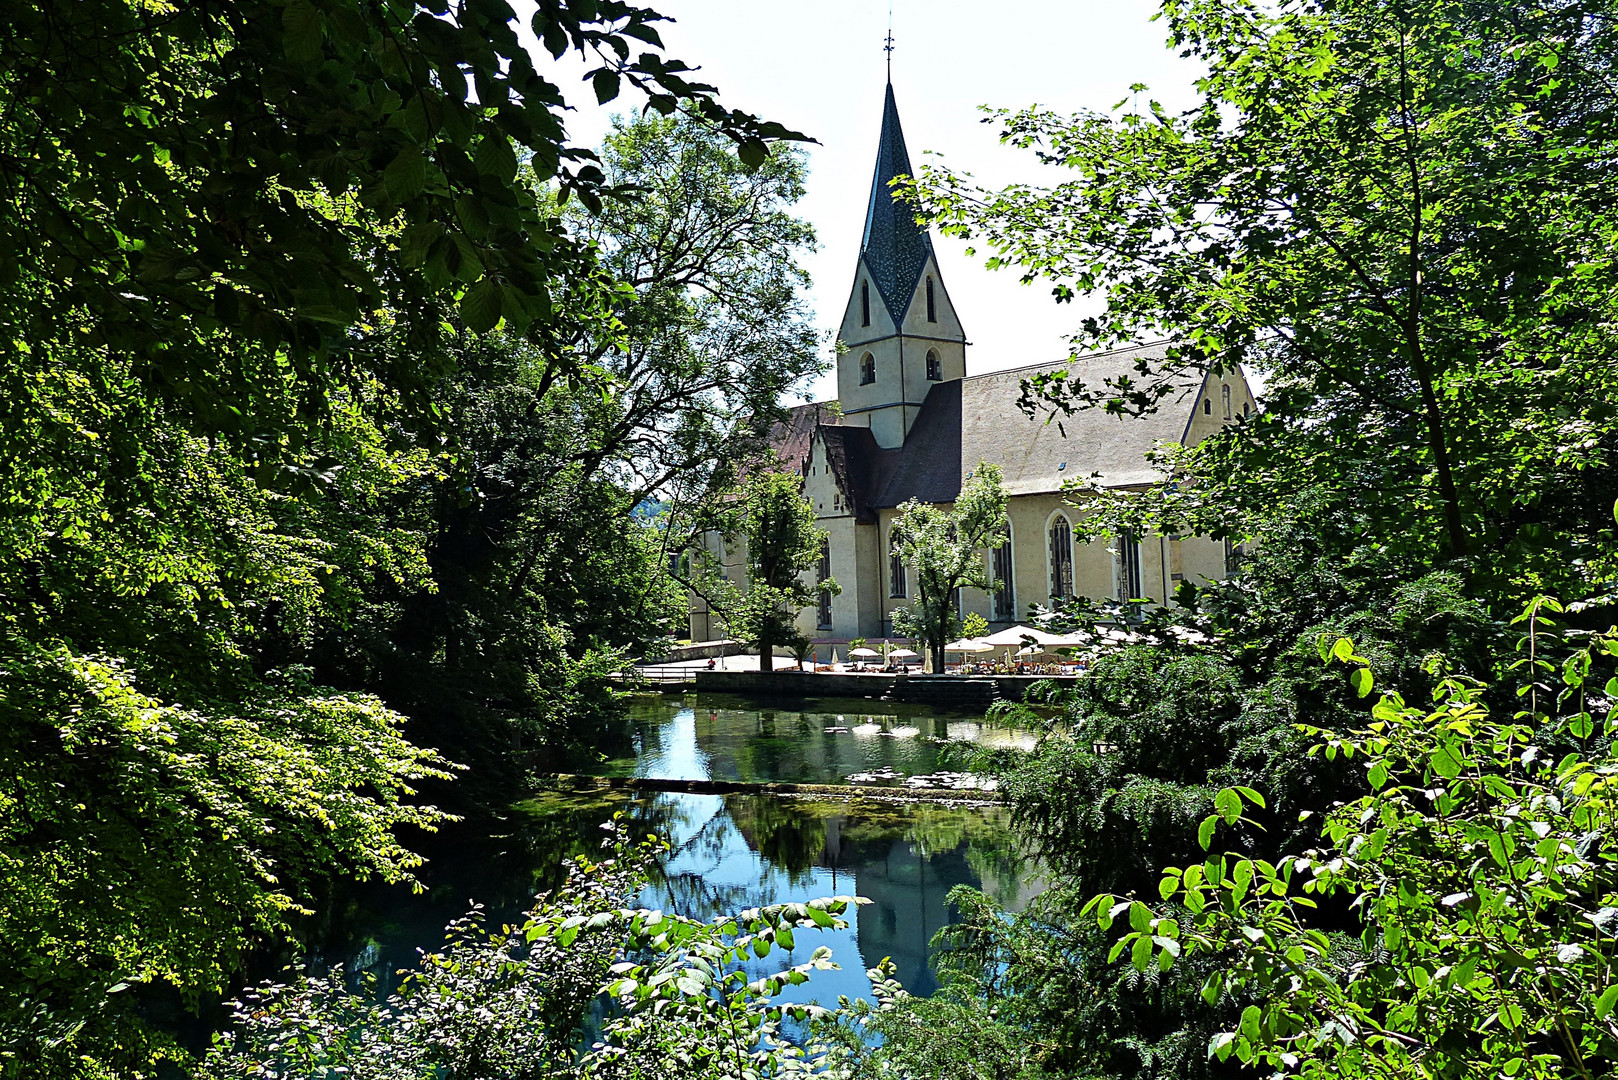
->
xmin=691 ymin=83 xmax=1257 ymax=657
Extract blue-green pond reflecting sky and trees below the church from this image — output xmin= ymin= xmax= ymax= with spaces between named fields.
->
xmin=316 ymin=695 xmax=1042 ymax=1004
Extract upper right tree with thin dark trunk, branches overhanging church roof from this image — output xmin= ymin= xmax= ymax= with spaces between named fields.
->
xmin=914 ymin=0 xmax=1618 ymax=594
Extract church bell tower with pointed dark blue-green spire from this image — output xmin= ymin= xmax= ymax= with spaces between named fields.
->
xmin=837 ymin=81 xmax=966 ymax=449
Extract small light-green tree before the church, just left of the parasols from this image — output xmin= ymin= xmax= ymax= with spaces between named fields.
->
xmin=892 ymin=461 xmax=1006 ymax=674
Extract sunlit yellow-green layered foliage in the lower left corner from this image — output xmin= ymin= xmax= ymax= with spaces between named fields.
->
xmin=0 ymin=643 xmax=451 ymax=1077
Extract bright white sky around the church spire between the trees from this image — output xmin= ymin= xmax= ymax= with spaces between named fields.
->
xmin=530 ymin=0 xmax=1199 ymax=400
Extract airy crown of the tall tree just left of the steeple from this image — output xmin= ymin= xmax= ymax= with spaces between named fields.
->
xmin=566 ymin=117 xmax=824 ymax=511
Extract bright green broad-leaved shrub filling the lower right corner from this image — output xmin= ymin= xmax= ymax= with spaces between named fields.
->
xmin=1106 ymin=599 xmax=1618 ymax=1080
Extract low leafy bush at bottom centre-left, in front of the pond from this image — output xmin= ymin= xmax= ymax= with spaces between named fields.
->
xmin=202 ymin=831 xmax=856 ymax=1080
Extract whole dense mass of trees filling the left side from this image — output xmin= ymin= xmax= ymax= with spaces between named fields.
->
xmin=0 ymin=0 xmax=815 ymax=1078
